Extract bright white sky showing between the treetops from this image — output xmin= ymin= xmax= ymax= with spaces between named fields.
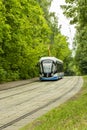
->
xmin=50 ymin=0 xmax=75 ymax=48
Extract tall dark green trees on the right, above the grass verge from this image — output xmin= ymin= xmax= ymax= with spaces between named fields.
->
xmin=62 ymin=0 xmax=87 ymax=74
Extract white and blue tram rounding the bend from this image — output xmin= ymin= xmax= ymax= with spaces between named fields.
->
xmin=39 ymin=57 xmax=64 ymax=81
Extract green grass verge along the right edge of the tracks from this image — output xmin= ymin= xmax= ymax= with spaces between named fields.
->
xmin=20 ymin=76 xmax=87 ymax=130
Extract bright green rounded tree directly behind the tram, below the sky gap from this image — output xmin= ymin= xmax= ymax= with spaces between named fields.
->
xmin=50 ymin=33 xmax=74 ymax=75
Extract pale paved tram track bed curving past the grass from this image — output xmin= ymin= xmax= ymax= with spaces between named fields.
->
xmin=0 ymin=77 xmax=83 ymax=130
